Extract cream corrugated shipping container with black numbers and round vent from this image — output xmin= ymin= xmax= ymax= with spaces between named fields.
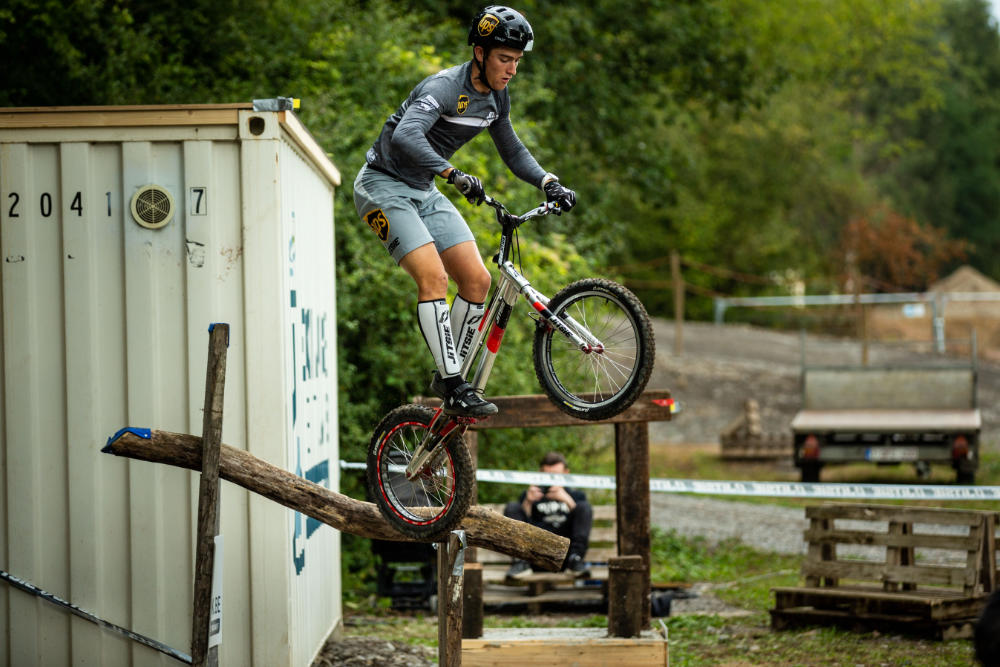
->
xmin=0 ymin=104 xmax=341 ymax=667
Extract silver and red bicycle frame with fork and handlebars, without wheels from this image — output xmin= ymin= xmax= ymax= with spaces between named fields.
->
xmin=406 ymin=197 xmax=604 ymax=481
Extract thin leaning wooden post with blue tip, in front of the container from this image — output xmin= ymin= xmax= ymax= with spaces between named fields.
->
xmin=191 ymin=324 xmax=229 ymax=667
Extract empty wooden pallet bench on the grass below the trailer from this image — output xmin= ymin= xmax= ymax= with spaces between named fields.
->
xmin=771 ymin=503 xmax=1000 ymax=639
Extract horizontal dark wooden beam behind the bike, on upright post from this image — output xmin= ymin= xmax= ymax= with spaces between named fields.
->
xmin=413 ymin=389 xmax=671 ymax=429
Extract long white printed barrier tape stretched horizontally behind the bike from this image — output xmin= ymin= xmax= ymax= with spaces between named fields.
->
xmin=340 ymin=461 xmax=1000 ymax=500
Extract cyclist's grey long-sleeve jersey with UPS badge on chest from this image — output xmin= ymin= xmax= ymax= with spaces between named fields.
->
xmin=367 ymin=61 xmax=545 ymax=190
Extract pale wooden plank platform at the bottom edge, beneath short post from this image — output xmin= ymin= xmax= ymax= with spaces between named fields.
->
xmin=462 ymin=628 xmax=669 ymax=667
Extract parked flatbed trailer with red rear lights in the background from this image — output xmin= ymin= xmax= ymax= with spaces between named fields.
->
xmin=792 ymin=352 xmax=982 ymax=484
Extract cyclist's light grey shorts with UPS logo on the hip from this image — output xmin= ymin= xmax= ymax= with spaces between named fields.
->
xmin=354 ymin=165 xmax=475 ymax=264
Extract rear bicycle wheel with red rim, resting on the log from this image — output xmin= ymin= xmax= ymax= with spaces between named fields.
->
xmin=367 ymin=405 xmax=473 ymax=539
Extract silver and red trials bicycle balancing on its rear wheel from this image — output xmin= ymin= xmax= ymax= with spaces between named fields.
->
xmin=367 ymin=196 xmax=655 ymax=539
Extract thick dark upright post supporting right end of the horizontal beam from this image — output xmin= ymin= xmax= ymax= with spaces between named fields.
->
xmin=608 ymin=422 xmax=651 ymax=627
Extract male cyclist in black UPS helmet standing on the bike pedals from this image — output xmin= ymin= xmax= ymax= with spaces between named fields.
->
xmin=354 ymin=5 xmax=576 ymax=417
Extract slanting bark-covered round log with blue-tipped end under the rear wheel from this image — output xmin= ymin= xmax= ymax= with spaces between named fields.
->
xmin=102 ymin=430 xmax=569 ymax=571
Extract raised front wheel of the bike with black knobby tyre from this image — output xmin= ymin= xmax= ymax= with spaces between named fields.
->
xmin=534 ymin=278 xmax=656 ymax=421
